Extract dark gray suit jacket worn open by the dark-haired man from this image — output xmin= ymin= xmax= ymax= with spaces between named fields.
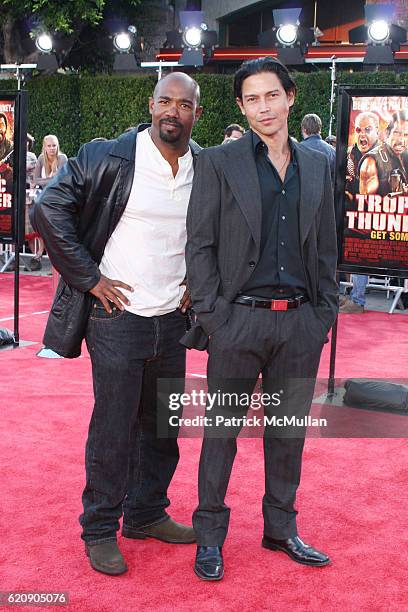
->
xmin=183 ymin=132 xmax=337 ymax=348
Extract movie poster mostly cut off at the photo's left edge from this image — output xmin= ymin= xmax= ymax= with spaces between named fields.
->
xmin=0 ymin=97 xmax=15 ymax=239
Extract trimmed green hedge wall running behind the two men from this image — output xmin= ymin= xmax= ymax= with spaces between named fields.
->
xmin=0 ymin=71 xmax=408 ymax=156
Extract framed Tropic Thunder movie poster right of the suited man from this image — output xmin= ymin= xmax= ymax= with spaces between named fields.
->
xmin=336 ymin=88 xmax=408 ymax=276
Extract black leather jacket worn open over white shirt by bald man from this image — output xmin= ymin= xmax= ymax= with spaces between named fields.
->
xmin=30 ymin=124 xmax=200 ymax=357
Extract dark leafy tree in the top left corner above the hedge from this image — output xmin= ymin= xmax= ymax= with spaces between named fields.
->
xmin=0 ymin=0 xmax=141 ymax=65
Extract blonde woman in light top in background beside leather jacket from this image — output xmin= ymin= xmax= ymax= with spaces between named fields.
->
xmin=30 ymin=134 xmax=68 ymax=270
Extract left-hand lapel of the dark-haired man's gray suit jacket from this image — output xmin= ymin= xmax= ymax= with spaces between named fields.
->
xmin=220 ymin=132 xmax=262 ymax=248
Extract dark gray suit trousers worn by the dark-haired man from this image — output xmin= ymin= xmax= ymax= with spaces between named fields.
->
xmin=193 ymin=303 xmax=327 ymax=546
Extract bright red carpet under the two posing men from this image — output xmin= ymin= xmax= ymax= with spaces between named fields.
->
xmin=0 ymin=274 xmax=408 ymax=612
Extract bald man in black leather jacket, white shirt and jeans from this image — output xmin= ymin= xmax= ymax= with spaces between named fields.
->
xmin=32 ymin=72 xmax=202 ymax=575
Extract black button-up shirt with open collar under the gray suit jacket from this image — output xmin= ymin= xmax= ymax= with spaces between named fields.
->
xmin=241 ymin=132 xmax=306 ymax=298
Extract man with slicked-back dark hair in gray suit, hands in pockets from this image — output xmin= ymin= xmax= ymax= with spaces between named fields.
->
xmin=184 ymin=58 xmax=337 ymax=580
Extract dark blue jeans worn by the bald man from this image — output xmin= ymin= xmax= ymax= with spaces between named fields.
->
xmin=80 ymin=300 xmax=186 ymax=544
